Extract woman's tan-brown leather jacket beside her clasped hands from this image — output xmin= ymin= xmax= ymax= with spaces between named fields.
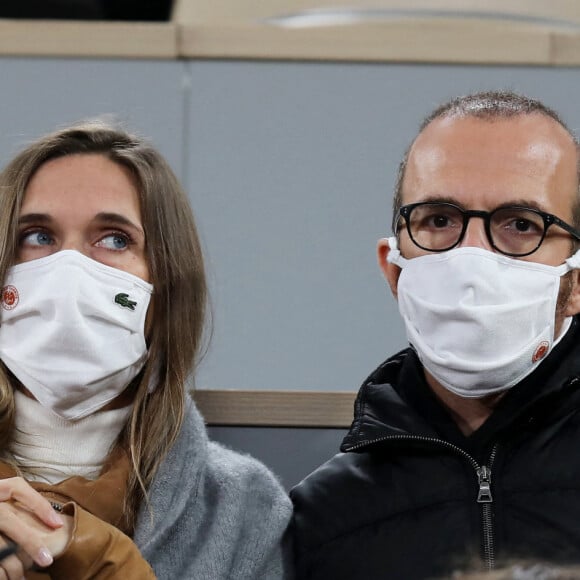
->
xmin=0 ymin=451 xmax=156 ymax=580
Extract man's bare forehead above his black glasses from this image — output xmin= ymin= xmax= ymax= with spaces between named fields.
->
xmin=403 ymin=113 xmax=578 ymax=216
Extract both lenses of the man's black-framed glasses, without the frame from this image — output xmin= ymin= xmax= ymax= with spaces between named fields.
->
xmin=407 ymin=203 xmax=545 ymax=256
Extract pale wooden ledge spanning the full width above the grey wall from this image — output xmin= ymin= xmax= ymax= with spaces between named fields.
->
xmin=0 ymin=0 xmax=580 ymax=61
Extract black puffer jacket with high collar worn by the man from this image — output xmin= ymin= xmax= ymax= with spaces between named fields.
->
xmin=291 ymin=320 xmax=580 ymax=580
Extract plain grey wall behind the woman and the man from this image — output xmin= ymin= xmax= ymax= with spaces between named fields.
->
xmin=0 ymin=58 xmax=580 ymax=390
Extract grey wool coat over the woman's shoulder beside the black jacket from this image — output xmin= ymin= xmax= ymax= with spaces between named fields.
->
xmin=134 ymin=400 xmax=292 ymax=580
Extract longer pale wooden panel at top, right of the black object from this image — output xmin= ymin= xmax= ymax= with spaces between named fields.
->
xmin=173 ymin=0 xmax=580 ymax=65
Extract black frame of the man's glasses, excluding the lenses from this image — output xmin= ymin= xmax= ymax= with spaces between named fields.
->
xmin=393 ymin=201 xmax=580 ymax=258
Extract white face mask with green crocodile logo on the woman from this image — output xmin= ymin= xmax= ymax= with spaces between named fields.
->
xmin=0 ymin=250 xmax=153 ymax=420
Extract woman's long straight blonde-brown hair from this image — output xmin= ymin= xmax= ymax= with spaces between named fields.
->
xmin=0 ymin=121 xmax=207 ymax=526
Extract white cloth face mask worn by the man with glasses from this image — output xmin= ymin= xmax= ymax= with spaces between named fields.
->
xmin=387 ymin=238 xmax=580 ymax=397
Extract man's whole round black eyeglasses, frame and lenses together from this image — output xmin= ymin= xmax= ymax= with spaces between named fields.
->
xmin=397 ymin=202 xmax=580 ymax=257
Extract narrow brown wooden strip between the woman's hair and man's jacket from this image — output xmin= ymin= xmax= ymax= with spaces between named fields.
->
xmin=192 ymin=389 xmax=356 ymax=427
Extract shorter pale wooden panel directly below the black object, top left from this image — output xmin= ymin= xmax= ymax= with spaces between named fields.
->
xmin=0 ymin=19 xmax=177 ymax=58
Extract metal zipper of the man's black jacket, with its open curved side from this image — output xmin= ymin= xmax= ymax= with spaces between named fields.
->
xmin=347 ymin=435 xmax=497 ymax=570
